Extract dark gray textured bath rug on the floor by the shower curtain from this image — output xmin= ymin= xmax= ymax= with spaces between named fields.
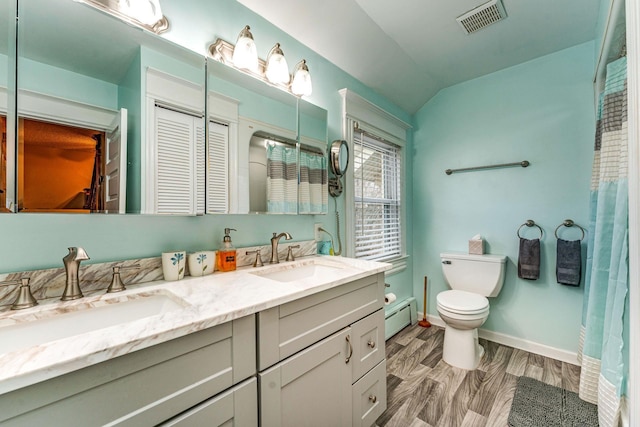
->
xmin=509 ymin=377 xmax=598 ymax=427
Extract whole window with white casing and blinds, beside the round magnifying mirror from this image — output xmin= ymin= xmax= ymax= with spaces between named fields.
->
xmin=336 ymin=89 xmax=411 ymax=274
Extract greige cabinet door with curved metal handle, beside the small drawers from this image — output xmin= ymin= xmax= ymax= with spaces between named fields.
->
xmin=258 ymin=328 xmax=353 ymax=427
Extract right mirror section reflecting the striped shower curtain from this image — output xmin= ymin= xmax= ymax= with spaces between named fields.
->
xmin=207 ymin=59 xmax=328 ymax=214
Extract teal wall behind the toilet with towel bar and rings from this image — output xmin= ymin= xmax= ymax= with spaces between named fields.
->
xmin=413 ymin=42 xmax=595 ymax=351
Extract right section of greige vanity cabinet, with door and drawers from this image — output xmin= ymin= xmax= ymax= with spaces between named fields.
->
xmin=258 ymin=273 xmax=386 ymax=427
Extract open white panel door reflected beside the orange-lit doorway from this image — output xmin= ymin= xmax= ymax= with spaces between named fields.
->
xmin=104 ymin=108 xmax=127 ymax=213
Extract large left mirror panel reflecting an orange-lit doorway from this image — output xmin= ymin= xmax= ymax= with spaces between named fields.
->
xmin=11 ymin=0 xmax=205 ymax=213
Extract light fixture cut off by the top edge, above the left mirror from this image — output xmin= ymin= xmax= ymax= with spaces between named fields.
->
xmin=75 ymin=0 xmax=169 ymax=34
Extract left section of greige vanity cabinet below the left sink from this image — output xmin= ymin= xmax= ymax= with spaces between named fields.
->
xmin=0 ymin=315 xmax=257 ymax=427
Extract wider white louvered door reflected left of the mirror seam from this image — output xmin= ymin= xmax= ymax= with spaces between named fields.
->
xmin=155 ymin=107 xmax=202 ymax=214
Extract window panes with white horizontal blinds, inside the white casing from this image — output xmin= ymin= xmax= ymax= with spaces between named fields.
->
xmin=353 ymin=130 xmax=402 ymax=260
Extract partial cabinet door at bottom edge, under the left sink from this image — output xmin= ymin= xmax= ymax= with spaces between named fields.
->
xmin=159 ymin=378 xmax=258 ymax=427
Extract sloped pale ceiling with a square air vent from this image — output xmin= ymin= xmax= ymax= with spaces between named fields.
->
xmin=238 ymin=0 xmax=600 ymax=113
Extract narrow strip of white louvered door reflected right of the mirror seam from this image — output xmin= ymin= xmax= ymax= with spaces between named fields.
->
xmin=207 ymin=122 xmax=229 ymax=213
